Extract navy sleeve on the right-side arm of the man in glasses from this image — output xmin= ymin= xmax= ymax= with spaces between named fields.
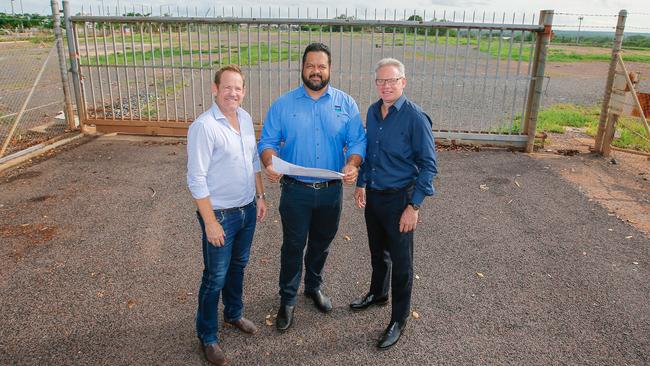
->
xmin=411 ymin=113 xmax=438 ymax=205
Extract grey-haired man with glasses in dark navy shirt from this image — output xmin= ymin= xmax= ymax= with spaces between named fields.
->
xmin=350 ymin=58 xmax=437 ymax=348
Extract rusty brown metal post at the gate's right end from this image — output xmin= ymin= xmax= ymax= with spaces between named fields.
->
xmin=523 ymin=10 xmax=553 ymax=153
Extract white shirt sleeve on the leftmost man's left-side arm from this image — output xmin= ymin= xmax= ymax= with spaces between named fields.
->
xmin=187 ymin=122 xmax=211 ymax=199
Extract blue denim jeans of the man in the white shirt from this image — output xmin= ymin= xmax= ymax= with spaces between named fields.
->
xmin=196 ymin=202 xmax=257 ymax=345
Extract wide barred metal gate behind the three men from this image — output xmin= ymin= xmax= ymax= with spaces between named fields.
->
xmin=66 ymin=6 xmax=553 ymax=150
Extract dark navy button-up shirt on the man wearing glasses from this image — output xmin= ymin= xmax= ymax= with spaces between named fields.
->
xmin=357 ymin=95 xmax=438 ymax=205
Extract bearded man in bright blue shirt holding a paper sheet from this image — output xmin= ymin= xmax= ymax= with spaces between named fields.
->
xmin=258 ymin=43 xmax=366 ymax=331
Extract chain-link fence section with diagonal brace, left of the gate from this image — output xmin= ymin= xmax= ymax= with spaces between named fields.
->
xmin=0 ymin=34 xmax=73 ymax=158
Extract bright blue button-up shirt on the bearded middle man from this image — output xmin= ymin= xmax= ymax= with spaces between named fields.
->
xmin=258 ymin=85 xmax=366 ymax=183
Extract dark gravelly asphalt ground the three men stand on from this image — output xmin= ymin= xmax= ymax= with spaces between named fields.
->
xmin=0 ymin=137 xmax=650 ymax=365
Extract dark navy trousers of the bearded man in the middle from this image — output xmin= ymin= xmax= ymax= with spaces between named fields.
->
xmin=279 ymin=183 xmax=343 ymax=305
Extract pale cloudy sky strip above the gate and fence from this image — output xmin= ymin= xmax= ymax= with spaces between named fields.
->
xmin=6 ymin=0 xmax=650 ymax=33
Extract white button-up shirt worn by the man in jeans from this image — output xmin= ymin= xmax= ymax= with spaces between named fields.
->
xmin=187 ymin=102 xmax=260 ymax=209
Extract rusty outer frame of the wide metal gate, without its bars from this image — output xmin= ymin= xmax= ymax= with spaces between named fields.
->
xmin=63 ymin=4 xmax=553 ymax=152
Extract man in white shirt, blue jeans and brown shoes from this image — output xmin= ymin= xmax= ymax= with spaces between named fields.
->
xmin=187 ymin=65 xmax=266 ymax=365
